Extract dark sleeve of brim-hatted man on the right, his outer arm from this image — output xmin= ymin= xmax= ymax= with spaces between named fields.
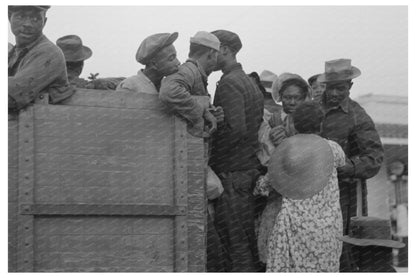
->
xmin=350 ymin=110 xmax=384 ymax=179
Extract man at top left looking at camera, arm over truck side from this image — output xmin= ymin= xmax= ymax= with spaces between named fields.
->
xmin=8 ymin=6 xmax=74 ymax=113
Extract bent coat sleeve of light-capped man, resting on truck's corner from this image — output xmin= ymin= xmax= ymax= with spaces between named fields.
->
xmin=159 ymin=67 xmax=204 ymax=125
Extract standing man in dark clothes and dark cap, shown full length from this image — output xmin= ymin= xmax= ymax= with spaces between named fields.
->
xmin=209 ymin=30 xmax=263 ymax=272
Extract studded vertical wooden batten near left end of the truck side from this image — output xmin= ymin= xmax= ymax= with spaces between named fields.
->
xmin=17 ymin=106 xmax=35 ymax=272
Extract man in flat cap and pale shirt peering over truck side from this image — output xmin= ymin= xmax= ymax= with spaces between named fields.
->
xmin=116 ymin=32 xmax=180 ymax=95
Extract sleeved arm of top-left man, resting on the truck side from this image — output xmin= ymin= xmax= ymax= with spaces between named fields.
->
xmin=8 ymin=47 xmax=65 ymax=110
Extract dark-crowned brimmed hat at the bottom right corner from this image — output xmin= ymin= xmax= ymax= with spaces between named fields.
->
xmin=340 ymin=216 xmax=405 ymax=248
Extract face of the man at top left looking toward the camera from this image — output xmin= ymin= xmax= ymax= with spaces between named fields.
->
xmin=10 ymin=8 xmax=46 ymax=46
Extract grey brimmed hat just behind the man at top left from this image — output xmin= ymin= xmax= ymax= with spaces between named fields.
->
xmin=56 ymin=35 xmax=92 ymax=62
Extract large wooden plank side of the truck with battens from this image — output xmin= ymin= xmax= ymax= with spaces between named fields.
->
xmin=8 ymin=89 xmax=207 ymax=272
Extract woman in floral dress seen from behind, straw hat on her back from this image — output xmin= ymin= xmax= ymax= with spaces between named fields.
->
xmin=267 ymin=102 xmax=345 ymax=272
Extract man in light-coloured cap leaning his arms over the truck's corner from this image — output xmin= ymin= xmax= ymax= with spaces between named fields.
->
xmin=159 ymin=31 xmax=221 ymax=136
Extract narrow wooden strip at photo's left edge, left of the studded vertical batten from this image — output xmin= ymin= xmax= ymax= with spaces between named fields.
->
xmin=8 ymin=115 xmax=18 ymax=272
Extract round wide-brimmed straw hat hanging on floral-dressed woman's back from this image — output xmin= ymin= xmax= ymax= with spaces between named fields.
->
xmin=268 ymin=134 xmax=334 ymax=199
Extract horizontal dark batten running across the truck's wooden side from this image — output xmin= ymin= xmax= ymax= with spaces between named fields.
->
xmin=20 ymin=204 xmax=187 ymax=216
